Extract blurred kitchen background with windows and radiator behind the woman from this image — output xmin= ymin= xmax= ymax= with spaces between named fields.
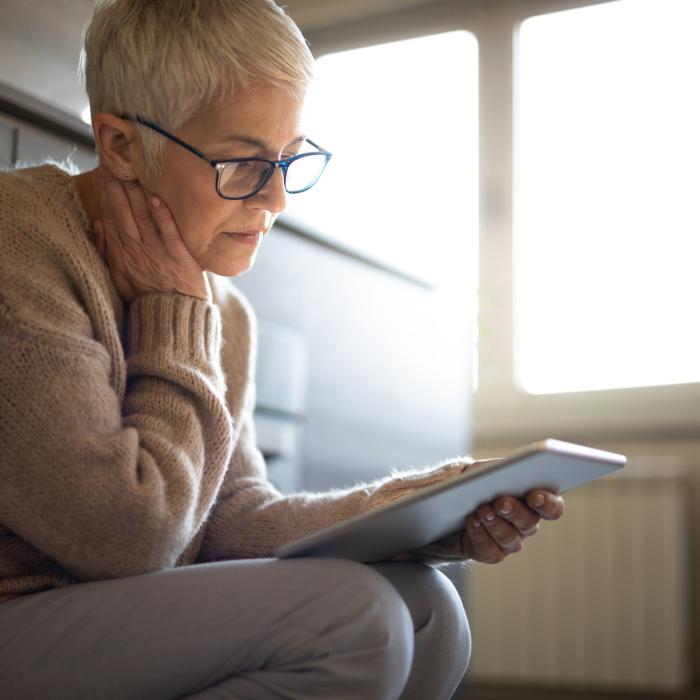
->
xmin=0 ymin=0 xmax=700 ymax=700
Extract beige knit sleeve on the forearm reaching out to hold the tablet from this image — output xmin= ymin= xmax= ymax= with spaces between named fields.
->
xmin=194 ymin=392 xmax=473 ymax=565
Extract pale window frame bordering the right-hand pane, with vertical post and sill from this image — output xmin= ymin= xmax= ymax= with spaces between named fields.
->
xmin=474 ymin=0 xmax=700 ymax=445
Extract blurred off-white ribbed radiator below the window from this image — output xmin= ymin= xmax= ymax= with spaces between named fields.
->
xmin=464 ymin=457 xmax=692 ymax=692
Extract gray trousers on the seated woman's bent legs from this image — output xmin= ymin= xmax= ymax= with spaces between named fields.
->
xmin=0 ymin=559 xmax=471 ymax=700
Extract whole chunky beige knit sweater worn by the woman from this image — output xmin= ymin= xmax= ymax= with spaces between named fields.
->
xmin=0 ymin=164 xmax=472 ymax=601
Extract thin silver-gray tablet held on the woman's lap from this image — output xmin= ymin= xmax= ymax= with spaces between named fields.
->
xmin=274 ymin=439 xmax=627 ymax=562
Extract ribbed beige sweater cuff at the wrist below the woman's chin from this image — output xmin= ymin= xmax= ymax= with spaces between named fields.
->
xmin=127 ymin=292 xmax=221 ymax=368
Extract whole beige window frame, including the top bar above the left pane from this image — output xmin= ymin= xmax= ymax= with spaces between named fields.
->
xmin=307 ymin=0 xmax=700 ymax=447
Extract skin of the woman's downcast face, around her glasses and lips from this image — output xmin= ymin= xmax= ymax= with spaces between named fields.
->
xmin=140 ymin=85 xmax=303 ymax=276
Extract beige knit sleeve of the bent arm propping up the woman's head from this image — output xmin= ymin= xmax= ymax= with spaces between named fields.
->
xmin=0 ymin=293 xmax=233 ymax=580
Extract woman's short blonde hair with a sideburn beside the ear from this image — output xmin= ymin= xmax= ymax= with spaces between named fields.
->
xmin=80 ymin=0 xmax=314 ymax=172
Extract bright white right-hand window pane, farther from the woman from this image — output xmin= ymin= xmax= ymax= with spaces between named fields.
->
xmin=514 ymin=0 xmax=700 ymax=394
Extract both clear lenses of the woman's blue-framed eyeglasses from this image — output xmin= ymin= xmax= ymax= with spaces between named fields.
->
xmin=219 ymin=153 xmax=326 ymax=197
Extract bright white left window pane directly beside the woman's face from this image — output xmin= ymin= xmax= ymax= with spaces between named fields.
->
xmin=287 ymin=31 xmax=478 ymax=289
